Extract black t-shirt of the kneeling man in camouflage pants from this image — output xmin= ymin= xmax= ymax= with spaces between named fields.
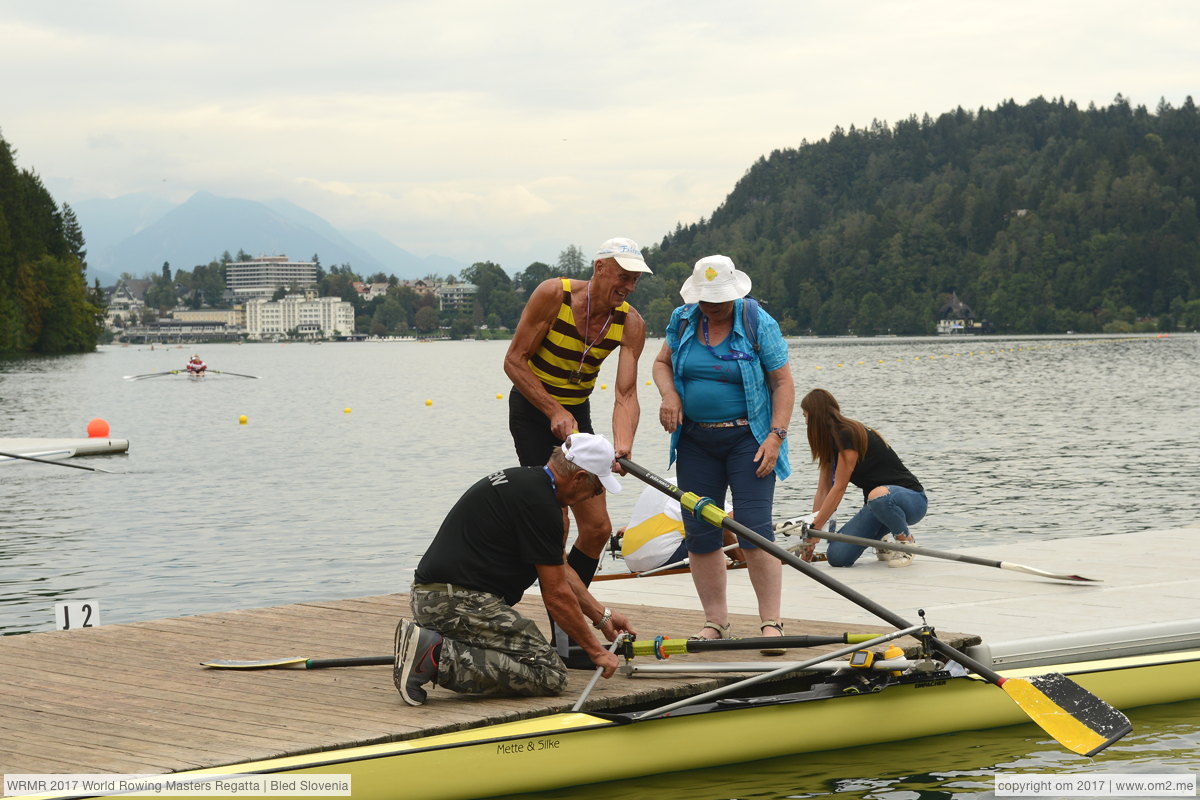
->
xmin=414 ymin=467 xmax=563 ymax=606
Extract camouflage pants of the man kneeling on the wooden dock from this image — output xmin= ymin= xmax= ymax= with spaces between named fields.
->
xmin=412 ymin=583 xmax=566 ymax=696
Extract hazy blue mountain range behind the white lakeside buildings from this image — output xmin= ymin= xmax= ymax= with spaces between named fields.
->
xmin=72 ymin=192 xmax=467 ymax=285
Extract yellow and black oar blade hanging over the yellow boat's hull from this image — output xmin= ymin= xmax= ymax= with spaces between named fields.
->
xmin=1000 ymin=672 xmax=1133 ymax=756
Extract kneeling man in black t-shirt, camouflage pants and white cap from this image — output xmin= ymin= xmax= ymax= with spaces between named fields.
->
xmin=394 ymin=433 xmax=635 ymax=705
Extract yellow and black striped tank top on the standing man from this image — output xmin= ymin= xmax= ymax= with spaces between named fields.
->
xmin=529 ymin=278 xmax=629 ymax=405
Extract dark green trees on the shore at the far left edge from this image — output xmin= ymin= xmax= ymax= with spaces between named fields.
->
xmin=0 ymin=138 xmax=103 ymax=353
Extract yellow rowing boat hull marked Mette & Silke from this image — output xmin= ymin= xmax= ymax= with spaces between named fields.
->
xmin=21 ymin=651 xmax=1200 ymax=800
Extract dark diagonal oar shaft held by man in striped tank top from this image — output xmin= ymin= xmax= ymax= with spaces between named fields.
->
xmin=617 ymin=458 xmax=1003 ymax=685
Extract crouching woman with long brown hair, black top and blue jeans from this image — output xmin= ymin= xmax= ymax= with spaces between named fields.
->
xmin=800 ymin=389 xmax=929 ymax=566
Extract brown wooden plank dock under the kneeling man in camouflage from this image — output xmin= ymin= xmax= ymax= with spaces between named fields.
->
xmin=0 ymin=594 xmax=978 ymax=774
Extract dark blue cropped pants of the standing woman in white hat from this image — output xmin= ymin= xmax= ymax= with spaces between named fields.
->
xmin=676 ymin=420 xmax=775 ymax=553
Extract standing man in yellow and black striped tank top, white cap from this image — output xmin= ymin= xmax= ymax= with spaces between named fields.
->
xmin=504 ymin=239 xmax=650 ymax=666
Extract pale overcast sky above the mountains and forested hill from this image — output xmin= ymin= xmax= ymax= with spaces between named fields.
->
xmin=0 ymin=0 xmax=1200 ymax=272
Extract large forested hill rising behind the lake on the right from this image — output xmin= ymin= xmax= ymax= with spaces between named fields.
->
xmin=652 ymin=95 xmax=1200 ymax=335
